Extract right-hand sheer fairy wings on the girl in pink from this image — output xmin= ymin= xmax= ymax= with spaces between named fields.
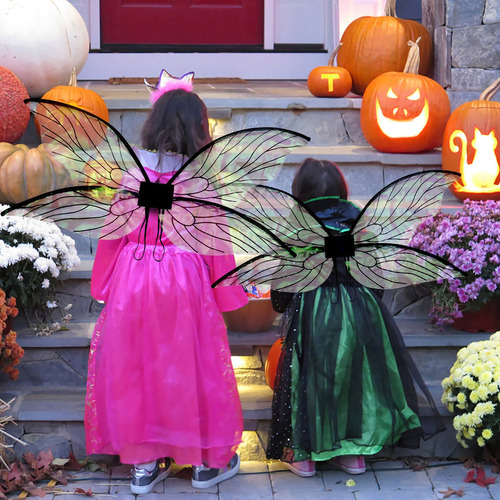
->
xmin=163 ymin=128 xmax=309 ymax=254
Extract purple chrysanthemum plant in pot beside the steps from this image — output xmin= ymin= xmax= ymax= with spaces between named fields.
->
xmin=411 ymin=200 xmax=500 ymax=332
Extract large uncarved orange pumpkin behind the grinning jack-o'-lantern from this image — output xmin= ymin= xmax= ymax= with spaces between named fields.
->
xmin=337 ymin=0 xmax=432 ymax=95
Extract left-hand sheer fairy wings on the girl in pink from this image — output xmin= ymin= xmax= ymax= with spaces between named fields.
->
xmin=2 ymin=99 xmax=148 ymax=238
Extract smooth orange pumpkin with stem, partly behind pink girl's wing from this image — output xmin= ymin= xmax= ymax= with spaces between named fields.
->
xmin=42 ymin=69 xmax=109 ymax=122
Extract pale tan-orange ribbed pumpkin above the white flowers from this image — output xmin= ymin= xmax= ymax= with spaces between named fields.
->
xmin=0 ymin=142 xmax=71 ymax=204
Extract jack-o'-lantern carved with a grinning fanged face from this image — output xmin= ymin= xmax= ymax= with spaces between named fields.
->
xmin=361 ymin=40 xmax=450 ymax=153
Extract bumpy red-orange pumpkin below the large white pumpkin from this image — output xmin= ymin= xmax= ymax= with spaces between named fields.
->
xmin=0 ymin=66 xmax=30 ymax=142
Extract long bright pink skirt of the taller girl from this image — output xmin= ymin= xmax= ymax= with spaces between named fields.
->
xmin=85 ymin=244 xmax=243 ymax=467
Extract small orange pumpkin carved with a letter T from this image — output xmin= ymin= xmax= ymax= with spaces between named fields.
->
xmin=307 ymin=43 xmax=352 ymax=97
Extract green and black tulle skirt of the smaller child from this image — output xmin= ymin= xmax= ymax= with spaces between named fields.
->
xmin=267 ymin=285 xmax=442 ymax=460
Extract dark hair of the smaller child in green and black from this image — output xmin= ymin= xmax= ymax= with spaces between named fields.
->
xmin=292 ymin=158 xmax=349 ymax=201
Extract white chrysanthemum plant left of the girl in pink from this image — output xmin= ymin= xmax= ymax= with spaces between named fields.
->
xmin=0 ymin=205 xmax=80 ymax=335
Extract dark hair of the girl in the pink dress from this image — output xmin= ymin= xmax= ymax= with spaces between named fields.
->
xmin=141 ymin=89 xmax=212 ymax=156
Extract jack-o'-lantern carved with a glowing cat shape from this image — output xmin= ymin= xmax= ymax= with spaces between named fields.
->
xmin=442 ymin=78 xmax=500 ymax=200
